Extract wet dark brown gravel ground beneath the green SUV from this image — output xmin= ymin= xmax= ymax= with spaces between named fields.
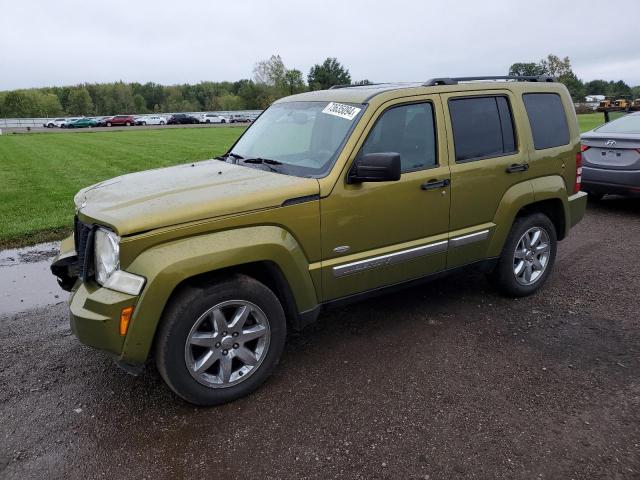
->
xmin=0 ymin=198 xmax=640 ymax=479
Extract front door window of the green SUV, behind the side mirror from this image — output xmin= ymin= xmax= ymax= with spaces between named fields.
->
xmin=362 ymin=103 xmax=437 ymax=172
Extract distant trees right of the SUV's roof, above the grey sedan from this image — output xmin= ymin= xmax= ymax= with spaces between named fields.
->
xmin=508 ymin=54 xmax=640 ymax=102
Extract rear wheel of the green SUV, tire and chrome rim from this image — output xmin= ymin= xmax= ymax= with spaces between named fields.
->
xmin=492 ymin=213 xmax=558 ymax=297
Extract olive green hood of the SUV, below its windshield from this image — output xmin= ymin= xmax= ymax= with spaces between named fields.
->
xmin=74 ymin=160 xmax=319 ymax=235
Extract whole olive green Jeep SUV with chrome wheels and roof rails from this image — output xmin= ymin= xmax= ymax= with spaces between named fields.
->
xmin=52 ymin=77 xmax=586 ymax=405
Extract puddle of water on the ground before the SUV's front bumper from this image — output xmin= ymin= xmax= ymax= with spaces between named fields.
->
xmin=0 ymin=243 xmax=69 ymax=315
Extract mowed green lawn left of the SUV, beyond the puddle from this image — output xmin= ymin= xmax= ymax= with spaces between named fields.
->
xmin=0 ymin=127 xmax=244 ymax=248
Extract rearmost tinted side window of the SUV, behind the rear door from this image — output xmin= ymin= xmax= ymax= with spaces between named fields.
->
xmin=522 ymin=93 xmax=569 ymax=150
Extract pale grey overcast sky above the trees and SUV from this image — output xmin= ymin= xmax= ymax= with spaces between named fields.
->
xmin=0 ymin=0 xmax=640 ymax=90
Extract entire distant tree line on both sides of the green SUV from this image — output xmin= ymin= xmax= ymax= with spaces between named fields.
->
xmin=0 ymin=55 xmax=640 ymax=118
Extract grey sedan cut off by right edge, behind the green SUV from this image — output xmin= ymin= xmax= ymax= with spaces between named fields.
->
xmin=581 ymin=112 xmax=640 ymax=200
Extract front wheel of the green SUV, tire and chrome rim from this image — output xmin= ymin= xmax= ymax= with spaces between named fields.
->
xmin=156 ymin=275 xmax=287 ymax=406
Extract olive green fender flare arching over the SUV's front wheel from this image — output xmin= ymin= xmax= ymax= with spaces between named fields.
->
xmin=120 ymin=226 xmax=318 ymax=364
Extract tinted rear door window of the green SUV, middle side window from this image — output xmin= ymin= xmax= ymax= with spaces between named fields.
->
xmin=449 ymin=97 xmax=516 ymax=162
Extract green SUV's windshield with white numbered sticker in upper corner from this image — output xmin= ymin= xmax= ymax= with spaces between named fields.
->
xmin=232 ymin=102 xmax=364 ymax=177
